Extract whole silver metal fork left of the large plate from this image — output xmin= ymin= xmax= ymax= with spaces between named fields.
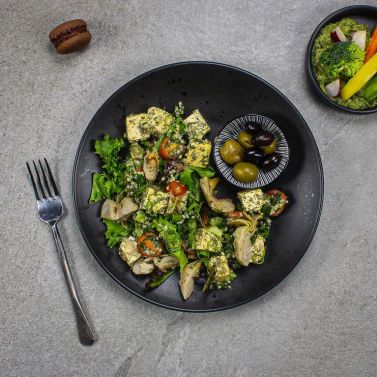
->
xmin=26 ymin=159 xmax=96 ymax=345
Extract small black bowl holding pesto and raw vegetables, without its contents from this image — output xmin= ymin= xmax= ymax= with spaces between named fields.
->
xmin=305 ymin=5 xmax=377 ymax=114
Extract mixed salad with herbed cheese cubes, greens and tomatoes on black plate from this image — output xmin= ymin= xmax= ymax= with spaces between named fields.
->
xmin=89 ymin=103 xmax=288 ymax=300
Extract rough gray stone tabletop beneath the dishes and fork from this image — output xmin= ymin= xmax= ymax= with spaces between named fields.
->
xmin=0 ymin=0 xmax=377 ymax=377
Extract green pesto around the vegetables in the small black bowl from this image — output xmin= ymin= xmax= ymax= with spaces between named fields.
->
xmin=312 ymin=18 xmax=377 ymax=110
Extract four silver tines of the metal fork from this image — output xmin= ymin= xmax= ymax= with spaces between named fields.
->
xmin=26 ymin=159 xmax=59 ymax=200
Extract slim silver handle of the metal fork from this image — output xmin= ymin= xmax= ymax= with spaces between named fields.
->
xmin=51 ymin=223 xmax=96 ymax=345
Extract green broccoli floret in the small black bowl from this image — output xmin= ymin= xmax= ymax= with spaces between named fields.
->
xmin=319 ymin=41 xmax=365 ymax=81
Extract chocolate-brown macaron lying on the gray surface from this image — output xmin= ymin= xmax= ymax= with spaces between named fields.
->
xmin=49 ymin=19 xmax=92 ymax=54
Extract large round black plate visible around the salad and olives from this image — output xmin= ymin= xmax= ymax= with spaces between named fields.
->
xmin=73 ymin=62 xmax=323 ymax=312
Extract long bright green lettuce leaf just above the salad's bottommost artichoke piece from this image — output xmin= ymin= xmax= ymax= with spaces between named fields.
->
xmin=153 ymin=216 xmax=188 ymax=271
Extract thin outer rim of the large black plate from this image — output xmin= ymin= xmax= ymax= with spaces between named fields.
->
xmin=71 ymin=60 xmax=324 ymax=313
